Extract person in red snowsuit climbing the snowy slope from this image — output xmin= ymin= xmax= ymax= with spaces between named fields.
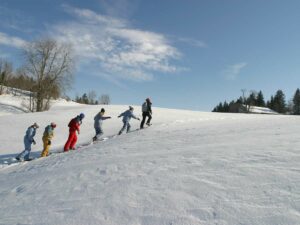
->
xmin=64 ymin=113 xmax=84 ymax=152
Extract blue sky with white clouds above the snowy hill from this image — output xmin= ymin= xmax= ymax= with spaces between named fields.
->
xmin=0 ymin=0 xmax=300 ymax=111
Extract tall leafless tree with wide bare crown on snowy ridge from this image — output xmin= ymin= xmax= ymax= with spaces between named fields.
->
xmin=24 ymin=39 xmax=73 ymax=112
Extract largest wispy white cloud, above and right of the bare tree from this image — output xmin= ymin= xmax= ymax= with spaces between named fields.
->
xmin=51 ymin=5 xmax=182 ymax=81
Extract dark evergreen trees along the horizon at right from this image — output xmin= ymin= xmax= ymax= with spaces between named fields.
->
xmin=212 ymin=88 xmax=300 ymax=115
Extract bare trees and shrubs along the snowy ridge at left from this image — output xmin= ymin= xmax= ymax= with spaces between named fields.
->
xmin=0 ymin=39 xmax=110 ymax=112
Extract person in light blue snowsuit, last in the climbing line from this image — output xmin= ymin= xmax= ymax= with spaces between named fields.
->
xmin=16 ymin=123 xmax=39 ymax=161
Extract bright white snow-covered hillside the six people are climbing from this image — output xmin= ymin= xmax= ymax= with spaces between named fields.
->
xmin=0 ymin=101 xmax=300 ymax=225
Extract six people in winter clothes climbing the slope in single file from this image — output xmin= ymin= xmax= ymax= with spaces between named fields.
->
xmin=16 ymin=98 xmax=152 ymax=161
